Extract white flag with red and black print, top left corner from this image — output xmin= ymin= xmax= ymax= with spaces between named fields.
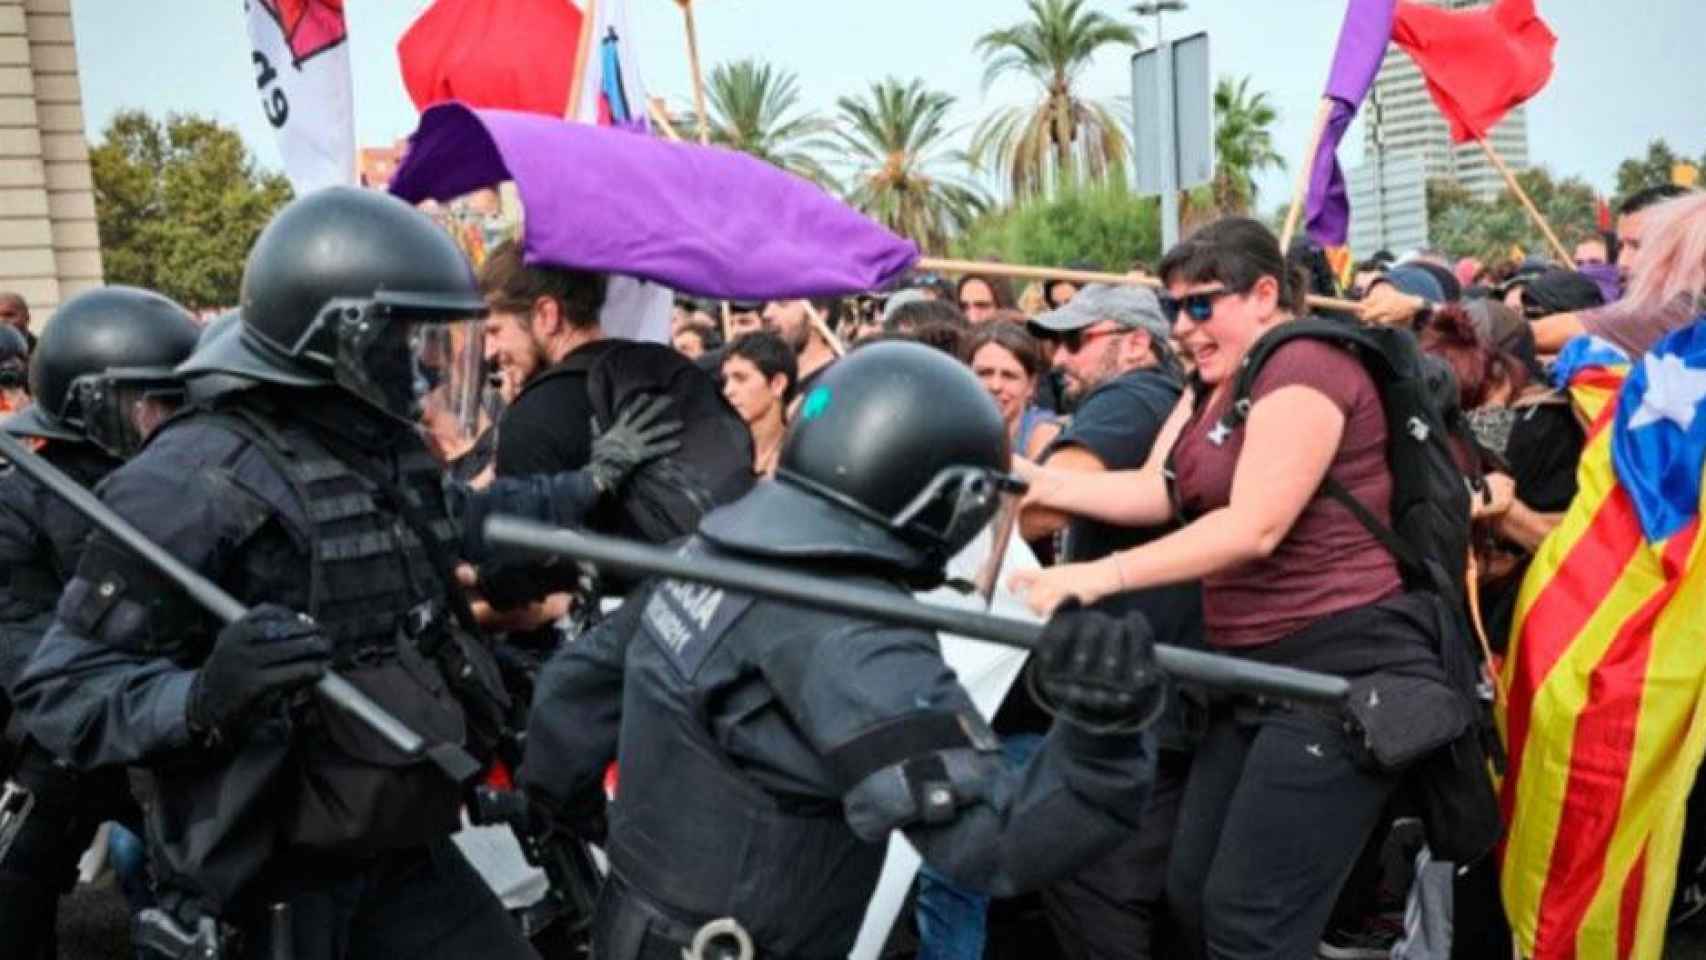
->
xmin=242 ymin=0 xmax=355 ymax=194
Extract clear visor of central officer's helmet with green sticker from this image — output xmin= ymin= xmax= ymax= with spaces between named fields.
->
xmin=891 ymin=467 xmax=1025 ymax=607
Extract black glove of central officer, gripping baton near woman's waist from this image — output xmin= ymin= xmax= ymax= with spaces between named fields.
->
xmin=1030 ymin=599 xmax=1165 ymax=733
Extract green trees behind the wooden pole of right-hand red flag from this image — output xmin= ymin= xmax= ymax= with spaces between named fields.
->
xmin=1428 ymin=167 xmax=1599 ymax=263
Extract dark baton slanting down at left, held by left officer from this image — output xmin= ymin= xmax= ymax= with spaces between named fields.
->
xmin=0 ymin=430 xmax=481 ymax=784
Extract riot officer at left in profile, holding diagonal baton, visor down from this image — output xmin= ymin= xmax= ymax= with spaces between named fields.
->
xmin=17 ymin=188 xmax=534 ymax=958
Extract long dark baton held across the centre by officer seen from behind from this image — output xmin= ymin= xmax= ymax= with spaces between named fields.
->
xmin=486 ymin=515 xmax=1349 ymax=704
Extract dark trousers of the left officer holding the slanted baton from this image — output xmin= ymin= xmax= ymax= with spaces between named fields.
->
xmin=237 ymin=837 xmax=539 ymax=960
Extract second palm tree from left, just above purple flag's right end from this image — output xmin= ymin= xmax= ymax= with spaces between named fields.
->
xmin=836 ymin=77 xmax=988 ymax=252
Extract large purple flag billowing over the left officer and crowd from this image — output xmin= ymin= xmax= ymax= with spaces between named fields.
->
xmin=391 ymin=102 xmax=918 ymax=300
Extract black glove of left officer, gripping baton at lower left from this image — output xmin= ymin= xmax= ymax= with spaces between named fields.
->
xmin=189 ymin=604 xmax=331 ymax=742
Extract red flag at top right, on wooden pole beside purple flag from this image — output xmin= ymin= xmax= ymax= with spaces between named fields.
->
xmin=1392 ymin=0 xmax=1558 ymax=143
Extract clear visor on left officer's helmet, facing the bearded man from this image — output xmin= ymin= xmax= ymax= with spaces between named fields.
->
xmin=334 ymin=302 xmax=490 ymax=446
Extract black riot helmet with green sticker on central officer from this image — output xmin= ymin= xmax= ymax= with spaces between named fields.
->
xmin=699 ymin=343 xmax=1022 ymax=583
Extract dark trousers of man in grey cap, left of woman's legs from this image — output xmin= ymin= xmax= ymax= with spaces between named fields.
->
xmin=1042 ymin=750 xmax=1191 ymax=960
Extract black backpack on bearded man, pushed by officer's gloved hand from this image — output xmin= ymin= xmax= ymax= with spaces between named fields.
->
xmin=548 ymin=341 xmax=754 ymax=544
